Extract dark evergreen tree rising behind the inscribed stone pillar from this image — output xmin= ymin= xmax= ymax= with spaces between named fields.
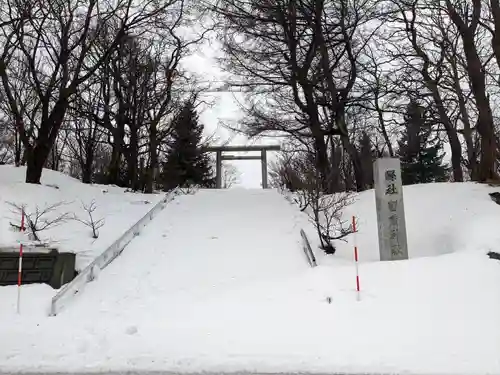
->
xmin=398 ymin=101 xmax=449 ymax=185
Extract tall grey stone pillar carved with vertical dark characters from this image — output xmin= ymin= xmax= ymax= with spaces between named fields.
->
xmin=373 ymin=158 xmax=408 ymax=260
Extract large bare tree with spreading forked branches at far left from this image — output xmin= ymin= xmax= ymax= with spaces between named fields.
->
xmin=0 ymin=0 xmax=184 ymax=183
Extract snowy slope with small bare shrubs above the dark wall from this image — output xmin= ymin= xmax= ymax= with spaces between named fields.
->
xmin=0 ymin=165 xmax=163 ymax=269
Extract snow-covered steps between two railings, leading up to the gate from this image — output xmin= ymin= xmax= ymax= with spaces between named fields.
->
xmin=63 ymin=189 xmax=308 ymax=317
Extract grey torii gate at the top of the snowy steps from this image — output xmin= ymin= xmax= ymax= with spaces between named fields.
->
xmin=203 ymin=145 xmax=281 ymax=189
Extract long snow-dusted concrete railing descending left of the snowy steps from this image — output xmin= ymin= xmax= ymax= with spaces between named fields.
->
xmin=50 ymin=190 xmax=179 ymax=316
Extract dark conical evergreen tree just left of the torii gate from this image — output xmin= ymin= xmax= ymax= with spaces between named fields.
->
xmin=161 ymin=101 xmax=215 ymax=190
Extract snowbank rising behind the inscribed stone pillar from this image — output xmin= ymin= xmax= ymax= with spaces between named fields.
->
xmin=308 ymin=183 xmax=500 ymax=264
